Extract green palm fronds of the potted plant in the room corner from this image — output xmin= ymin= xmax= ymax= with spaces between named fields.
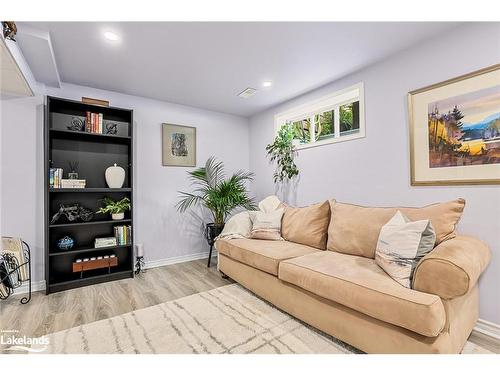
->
xmin=176 ymin=156 xmax=256 ymax=225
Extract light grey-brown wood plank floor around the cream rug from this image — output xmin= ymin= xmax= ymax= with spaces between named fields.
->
xmin=0 ymin=259 xmax=500 ymax=353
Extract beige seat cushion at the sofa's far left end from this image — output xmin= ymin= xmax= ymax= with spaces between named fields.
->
xmin=215 ymin=239 xmax=319 ymax=276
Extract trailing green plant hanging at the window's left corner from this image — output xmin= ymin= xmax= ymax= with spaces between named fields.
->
xmin=266 ymin=123 xmax=299 ymax=183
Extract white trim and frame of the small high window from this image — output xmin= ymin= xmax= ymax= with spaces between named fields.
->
xmin=274 ymin=82 xmax=366 ymax=150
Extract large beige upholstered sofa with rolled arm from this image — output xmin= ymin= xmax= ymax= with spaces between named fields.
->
xmin=216 ymin=199 xmax=490 ymax=353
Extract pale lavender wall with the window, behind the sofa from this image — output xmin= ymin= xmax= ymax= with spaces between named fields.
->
xmin=250 ymin=23 xmax=500 ymax=324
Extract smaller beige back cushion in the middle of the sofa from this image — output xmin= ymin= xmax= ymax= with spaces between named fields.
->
xmin=281 ymin=201 xmax=330 ymax=250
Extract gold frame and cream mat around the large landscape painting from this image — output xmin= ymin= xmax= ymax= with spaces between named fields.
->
xmin=407 ymin=64 xmax=500 ymax=186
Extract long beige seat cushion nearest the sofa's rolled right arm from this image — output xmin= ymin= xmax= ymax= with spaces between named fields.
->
xmin=278 ymin=251 xmax=446 ymax=337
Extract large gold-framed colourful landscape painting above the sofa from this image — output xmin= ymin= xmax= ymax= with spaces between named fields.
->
xmin=408 ymin=64 xmax=500 ymax=185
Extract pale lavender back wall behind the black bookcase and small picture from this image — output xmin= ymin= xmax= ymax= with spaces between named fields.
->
xmin=0 ymin=84 xmax=249 ymax=281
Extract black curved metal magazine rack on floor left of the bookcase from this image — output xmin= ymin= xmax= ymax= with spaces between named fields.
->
xmin=0 ymin=241 xmax=31 ymax=305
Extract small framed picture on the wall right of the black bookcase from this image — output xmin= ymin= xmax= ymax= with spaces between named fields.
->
xmin=162 ymin=124 xmax=196 ymax=167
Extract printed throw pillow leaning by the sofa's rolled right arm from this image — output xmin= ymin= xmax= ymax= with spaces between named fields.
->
xmin=375 ymin=211 xmax=436 ymax=288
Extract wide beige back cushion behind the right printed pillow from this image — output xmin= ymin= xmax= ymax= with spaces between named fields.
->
xmin=327 ymin=199 xmax=465 ymax=258
